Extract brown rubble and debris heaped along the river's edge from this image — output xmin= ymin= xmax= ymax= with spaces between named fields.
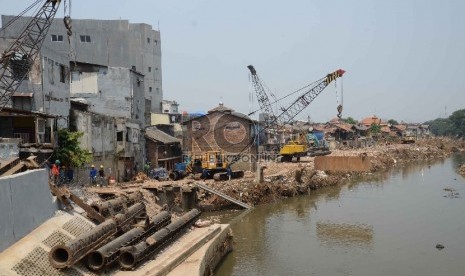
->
xmin=195 ymin=138 xmax=465 ymax=209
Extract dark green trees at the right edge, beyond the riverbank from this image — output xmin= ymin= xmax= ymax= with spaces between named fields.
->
xmin=425 ymin=109 xmax=465 ymax=137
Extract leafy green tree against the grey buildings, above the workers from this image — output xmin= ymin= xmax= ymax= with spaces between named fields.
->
xmin=54 ymin=129 xmax=92 ymax=168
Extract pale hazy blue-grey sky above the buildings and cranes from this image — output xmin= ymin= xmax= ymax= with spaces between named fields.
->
xmin=0 ymin=0 xmax=465 ymax=122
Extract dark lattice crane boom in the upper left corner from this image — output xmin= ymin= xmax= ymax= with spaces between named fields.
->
xmin=0 ymin=0 xmax=61 ymax=111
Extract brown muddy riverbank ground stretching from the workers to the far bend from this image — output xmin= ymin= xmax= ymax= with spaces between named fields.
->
xmin=83 ymin=138 xmax=465 ymax=212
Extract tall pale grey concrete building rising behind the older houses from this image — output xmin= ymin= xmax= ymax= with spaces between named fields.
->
xmin=2 ymin=16 xmax=163 ymax=112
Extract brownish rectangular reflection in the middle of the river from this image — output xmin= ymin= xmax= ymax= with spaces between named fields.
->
xmin=316 ymin=222 xmax=373 ymax=250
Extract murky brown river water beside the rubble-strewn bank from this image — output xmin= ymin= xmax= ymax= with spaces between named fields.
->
xmin=216 ymin=155 xmax=465 ymax=276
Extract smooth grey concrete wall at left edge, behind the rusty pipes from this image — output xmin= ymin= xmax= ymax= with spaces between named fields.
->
xmin=0 ymin=169 xmax=57 ymax=251
